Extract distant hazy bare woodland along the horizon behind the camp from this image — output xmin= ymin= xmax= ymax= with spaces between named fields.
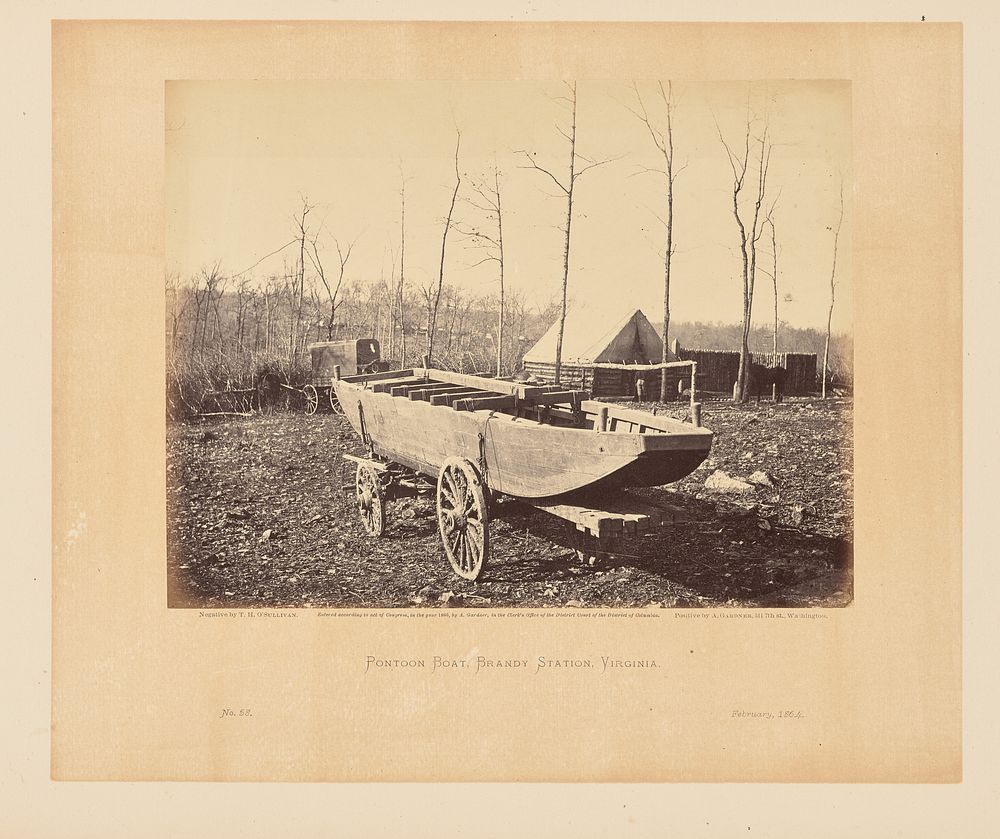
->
xmin=166 ymin=269 xmax=852 ymax=413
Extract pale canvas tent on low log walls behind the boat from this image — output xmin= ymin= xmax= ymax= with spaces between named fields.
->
xmin=524 ymin=306 xmax=677 ymax=396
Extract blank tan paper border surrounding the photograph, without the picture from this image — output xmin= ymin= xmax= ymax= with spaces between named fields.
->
xmin=52 ymin=14 xmax=962 ymax=782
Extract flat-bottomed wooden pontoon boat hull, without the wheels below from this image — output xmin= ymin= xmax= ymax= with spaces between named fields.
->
xmin=333 ymin=371 xmax=712 ymax=498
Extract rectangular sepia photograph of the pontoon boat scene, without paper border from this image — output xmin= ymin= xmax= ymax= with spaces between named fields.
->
xmin=165 ymin=78 xmax=854 ymax=609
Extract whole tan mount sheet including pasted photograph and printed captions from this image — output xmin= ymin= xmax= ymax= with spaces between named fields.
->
xmin=51 ymin=21 xmax=962 ymax=792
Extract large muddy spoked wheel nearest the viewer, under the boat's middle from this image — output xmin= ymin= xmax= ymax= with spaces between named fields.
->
xmin=437 ymin=457 xmax=490 ymax=580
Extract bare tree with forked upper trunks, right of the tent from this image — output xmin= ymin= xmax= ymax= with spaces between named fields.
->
xmin=716 ymin=102 xmax=771 ymax=402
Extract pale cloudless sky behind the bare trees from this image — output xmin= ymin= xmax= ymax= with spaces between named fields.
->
xmin=166 ymin=81 xmax=852 ymax=332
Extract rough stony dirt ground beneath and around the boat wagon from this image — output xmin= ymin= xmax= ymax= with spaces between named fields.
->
xmin=167 ymin=398 xmax=854 ymax=608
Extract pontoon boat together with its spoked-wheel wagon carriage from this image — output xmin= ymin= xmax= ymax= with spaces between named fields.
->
xmin=332 ymin=368 xmax=712 ymax=580
